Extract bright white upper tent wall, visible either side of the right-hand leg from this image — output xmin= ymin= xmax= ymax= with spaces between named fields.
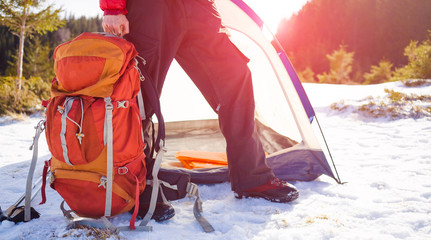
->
xmin=161 ymin=0 xmax=326 ymax=149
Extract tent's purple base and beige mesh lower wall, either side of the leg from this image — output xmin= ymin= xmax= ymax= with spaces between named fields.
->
xmin=162 ymin=120 xmax=334 ymax=184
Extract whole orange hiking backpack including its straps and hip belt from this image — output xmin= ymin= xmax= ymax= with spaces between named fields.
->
xmin=24 ymin=33 xmax=214 ymax=232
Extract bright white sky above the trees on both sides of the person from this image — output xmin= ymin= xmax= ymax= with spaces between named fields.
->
xmin=47 ymin=0 xmax=308 ymax=32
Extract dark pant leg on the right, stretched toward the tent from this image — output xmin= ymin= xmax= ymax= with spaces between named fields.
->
xmin=176 ymin=0 xmax=274 ymax=191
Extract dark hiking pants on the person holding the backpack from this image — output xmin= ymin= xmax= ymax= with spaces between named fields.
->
xmin=127 ymin=0 xmax=274 ymax=191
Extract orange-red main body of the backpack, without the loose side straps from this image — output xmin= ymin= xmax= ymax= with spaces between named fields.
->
xmin=46 ymin=33 xmax=146 ymax=229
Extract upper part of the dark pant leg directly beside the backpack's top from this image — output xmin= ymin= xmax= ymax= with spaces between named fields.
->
xmin=126 ymin=0 xmax=185 ymax=96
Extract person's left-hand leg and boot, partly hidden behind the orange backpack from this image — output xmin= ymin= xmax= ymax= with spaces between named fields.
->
xmin=126 ymin=0 xmax=184 ymax=221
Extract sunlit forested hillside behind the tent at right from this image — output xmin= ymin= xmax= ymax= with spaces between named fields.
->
xmin=277 ymin=0 xmax=431 ymax=83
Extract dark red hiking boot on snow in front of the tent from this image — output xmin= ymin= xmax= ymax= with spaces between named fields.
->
xmin=235 ymin=178 xmax=299 ymax=203
